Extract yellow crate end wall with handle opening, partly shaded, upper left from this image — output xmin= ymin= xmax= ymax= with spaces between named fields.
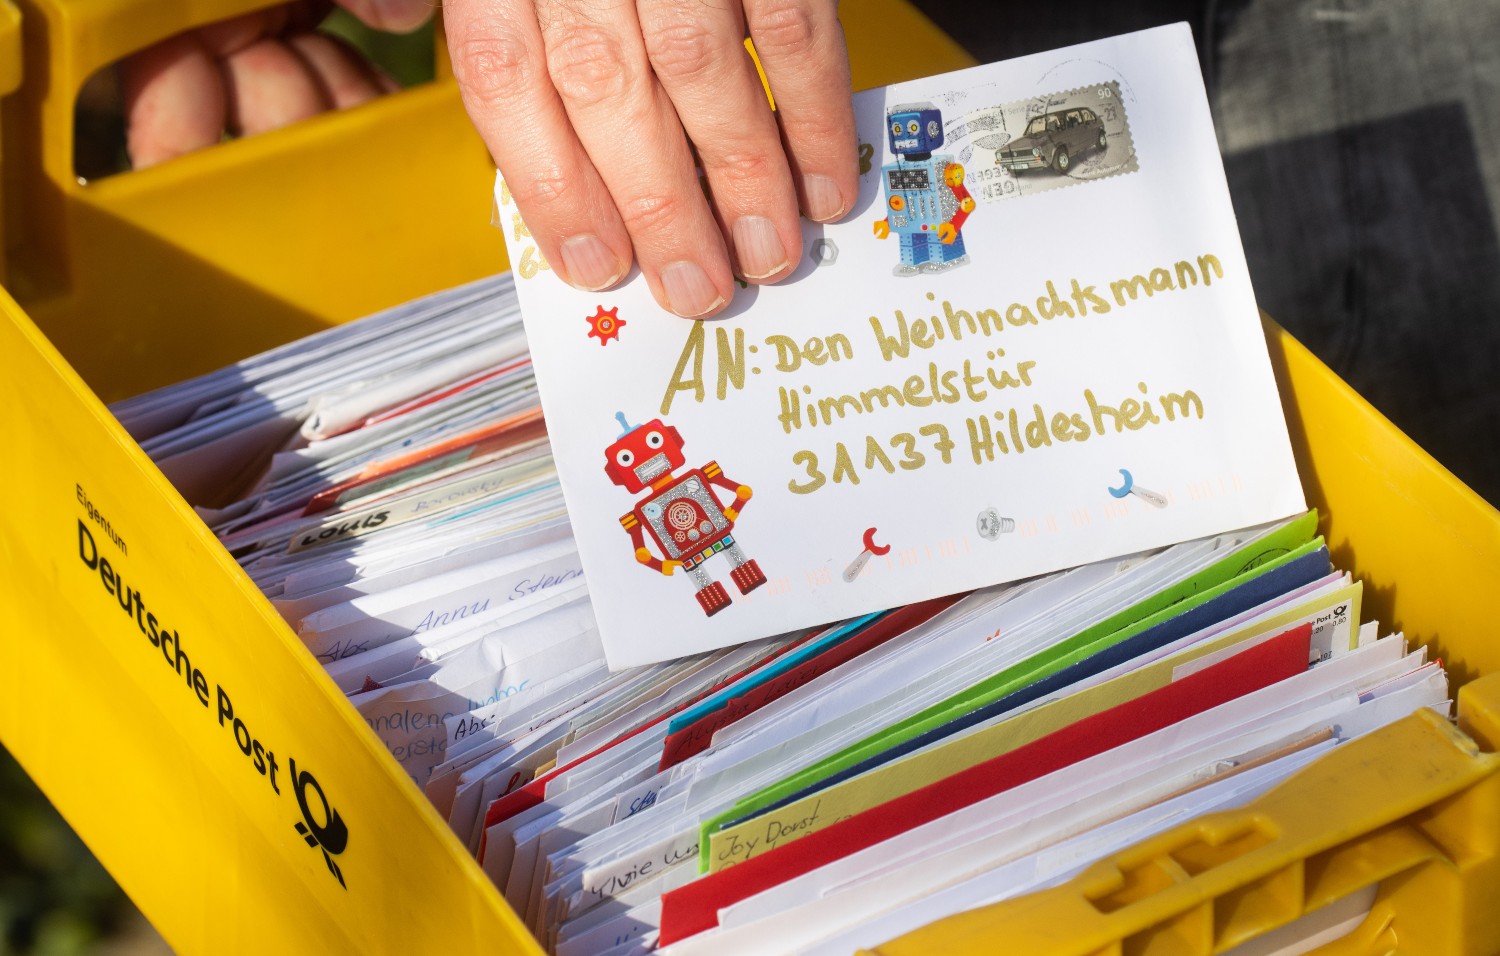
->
xmin=5 ymin=0 xmax=506 ymax=401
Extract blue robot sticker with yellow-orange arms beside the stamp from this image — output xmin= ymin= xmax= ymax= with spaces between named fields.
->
xmin=875 ymin=102 xmax=974 ymax=276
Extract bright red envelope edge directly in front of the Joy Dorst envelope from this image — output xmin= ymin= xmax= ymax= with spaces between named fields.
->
xmin=660 ymin=624 xmax=1313 ymax=945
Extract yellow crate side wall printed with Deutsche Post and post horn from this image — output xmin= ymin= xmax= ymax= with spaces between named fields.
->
xmin=0 ymin=286 xmax=546 ymax=953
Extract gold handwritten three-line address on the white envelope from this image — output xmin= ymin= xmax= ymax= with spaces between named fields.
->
xmin=662 ymin=254 xmax=1224 ymax=494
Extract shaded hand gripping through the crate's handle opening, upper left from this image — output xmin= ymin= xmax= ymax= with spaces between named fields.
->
xmin=120 ymin=0 xmax=434 ymax=168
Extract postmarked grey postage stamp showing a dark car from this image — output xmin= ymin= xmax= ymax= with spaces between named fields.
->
xmin=945 ymin=80 xmax=1137 ymax=203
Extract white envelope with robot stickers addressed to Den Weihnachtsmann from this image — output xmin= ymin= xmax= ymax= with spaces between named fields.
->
xmin=497 ymin=27 xmax=1304 ymax=666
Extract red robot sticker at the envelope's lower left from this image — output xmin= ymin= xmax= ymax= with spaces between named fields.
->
xmin=605 ymin=411 xmax=765 ymax=617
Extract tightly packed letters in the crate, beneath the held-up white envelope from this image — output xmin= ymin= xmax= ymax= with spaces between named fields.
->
xmin=116 ymin=271 xmax=1448 ymax=956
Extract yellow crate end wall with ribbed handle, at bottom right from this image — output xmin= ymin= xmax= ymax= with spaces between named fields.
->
xmin=867 ymin=675 xmax=1500 ymax=956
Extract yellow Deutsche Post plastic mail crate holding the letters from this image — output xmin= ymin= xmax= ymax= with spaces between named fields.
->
xmin=0 ymin=0 xmax=1500 ymax=953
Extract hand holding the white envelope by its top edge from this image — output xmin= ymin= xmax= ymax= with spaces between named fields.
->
xmin=444 ymin=0 xmax=858 ymax=318
